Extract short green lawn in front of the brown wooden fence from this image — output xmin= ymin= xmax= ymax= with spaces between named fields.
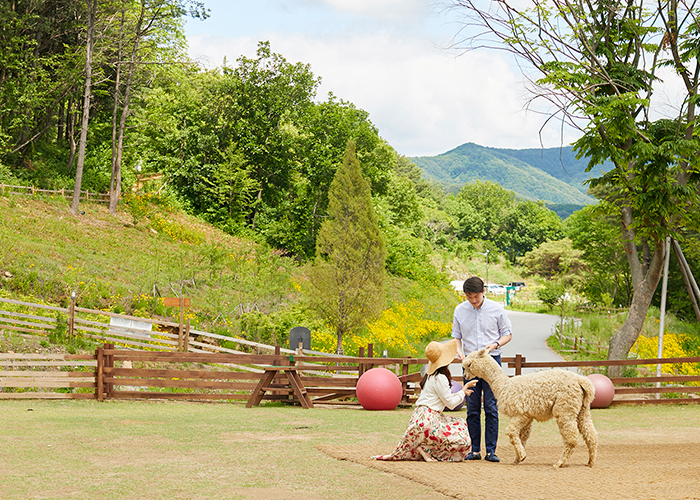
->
xmin=0 ymin=401 xmax=700 ymax=500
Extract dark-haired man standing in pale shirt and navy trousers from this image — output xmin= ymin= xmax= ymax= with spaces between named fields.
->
xmin=452 ymin=276 xmax=513 ymax=462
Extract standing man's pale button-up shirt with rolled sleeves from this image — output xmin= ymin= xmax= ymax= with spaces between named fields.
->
xmin=452 ymin=297 xmax=513 ymax=356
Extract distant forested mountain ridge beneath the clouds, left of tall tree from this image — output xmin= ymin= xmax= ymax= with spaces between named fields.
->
xmin=411 ymin=143 xmax=612 ymax=205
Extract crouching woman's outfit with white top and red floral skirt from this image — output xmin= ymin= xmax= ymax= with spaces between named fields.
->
xmin=372 ymin=375 xmax=471 ymax=462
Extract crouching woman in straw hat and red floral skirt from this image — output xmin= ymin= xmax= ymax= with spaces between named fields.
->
xmin=372 ymin=339 xmax=477 ymax=462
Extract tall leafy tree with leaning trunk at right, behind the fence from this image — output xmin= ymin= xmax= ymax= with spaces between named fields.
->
xmin=453 ymin=0 xmax=700 ymax=368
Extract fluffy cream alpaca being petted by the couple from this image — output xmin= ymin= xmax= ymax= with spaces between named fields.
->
xmin=462 ymin=349 xmax=598 ymax=469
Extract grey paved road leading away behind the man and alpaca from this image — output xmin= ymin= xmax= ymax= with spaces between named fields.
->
xmin=450 ymin=310 xmax=564 ymax=375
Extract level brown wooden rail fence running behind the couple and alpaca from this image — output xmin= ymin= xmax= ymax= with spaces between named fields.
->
xmin=0 ymin=344 xmax=700 ymax=407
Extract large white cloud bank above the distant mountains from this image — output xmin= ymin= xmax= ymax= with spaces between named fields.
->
xmin=189 ymin=4 xmax=571 ymax=156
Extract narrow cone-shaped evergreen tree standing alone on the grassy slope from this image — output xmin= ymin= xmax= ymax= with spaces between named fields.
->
xmin=310 ymin=141 xmax=386 ymax=354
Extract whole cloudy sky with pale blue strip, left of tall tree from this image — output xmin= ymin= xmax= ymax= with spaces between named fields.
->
xmin=186 ymin=0 xmax=576 ymax=156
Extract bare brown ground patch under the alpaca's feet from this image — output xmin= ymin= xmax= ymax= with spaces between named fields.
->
xmin=317 ymin=442 xmax=700 ymax=500
